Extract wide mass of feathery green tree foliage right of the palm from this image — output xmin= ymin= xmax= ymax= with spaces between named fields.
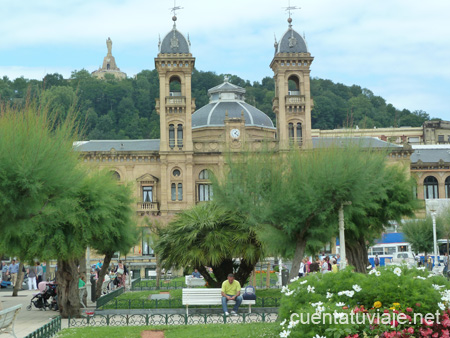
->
xmin=213 ymin=143 xmax=414 ymax=273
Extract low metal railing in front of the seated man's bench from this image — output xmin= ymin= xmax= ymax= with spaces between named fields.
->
xmin=69 ymin=312 xmax=278 ymax=327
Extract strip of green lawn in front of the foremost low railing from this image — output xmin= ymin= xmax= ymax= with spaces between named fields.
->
xmin=57 ymin=323 xmax=280 ymax=338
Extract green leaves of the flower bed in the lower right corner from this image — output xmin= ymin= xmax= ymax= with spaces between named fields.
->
xmin=279 ymin=267 xmax=450 ymax=337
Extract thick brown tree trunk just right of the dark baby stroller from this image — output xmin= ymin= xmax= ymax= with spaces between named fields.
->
xmin=56 ymin=259 xmax=80 ymax=318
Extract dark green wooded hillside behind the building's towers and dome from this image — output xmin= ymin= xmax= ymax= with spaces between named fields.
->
xmin=0 ymin=69 xmax=430 ymax=139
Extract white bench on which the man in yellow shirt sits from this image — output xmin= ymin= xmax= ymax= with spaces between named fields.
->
xmin=182 ymin=288 xmax=256 ymax=315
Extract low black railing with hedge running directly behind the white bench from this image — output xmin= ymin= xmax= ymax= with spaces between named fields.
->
xmin=97 ymin=297 xmax=281 ymax=310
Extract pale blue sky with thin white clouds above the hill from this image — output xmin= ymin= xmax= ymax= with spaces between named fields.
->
xmin=0 ymin=0 xmax=450 ymax=120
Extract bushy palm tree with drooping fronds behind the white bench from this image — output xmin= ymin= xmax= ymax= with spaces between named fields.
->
xmin=155 ymin=202 xmax=263 ymax=287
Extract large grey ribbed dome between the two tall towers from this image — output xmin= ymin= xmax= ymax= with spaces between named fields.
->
xmin=192 ymin=78 xmax=274 ymax=128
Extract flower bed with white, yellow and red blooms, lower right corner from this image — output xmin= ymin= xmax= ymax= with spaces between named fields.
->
xmin=279 ymin=267 xmax=450 ymax=338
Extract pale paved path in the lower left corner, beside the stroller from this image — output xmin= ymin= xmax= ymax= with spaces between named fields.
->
xmin=0 ymin=289 xmax=93 ymax=338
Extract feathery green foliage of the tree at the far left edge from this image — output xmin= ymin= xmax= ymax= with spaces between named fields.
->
xmin=0 ymin=104 xmax=82 ymax=258
